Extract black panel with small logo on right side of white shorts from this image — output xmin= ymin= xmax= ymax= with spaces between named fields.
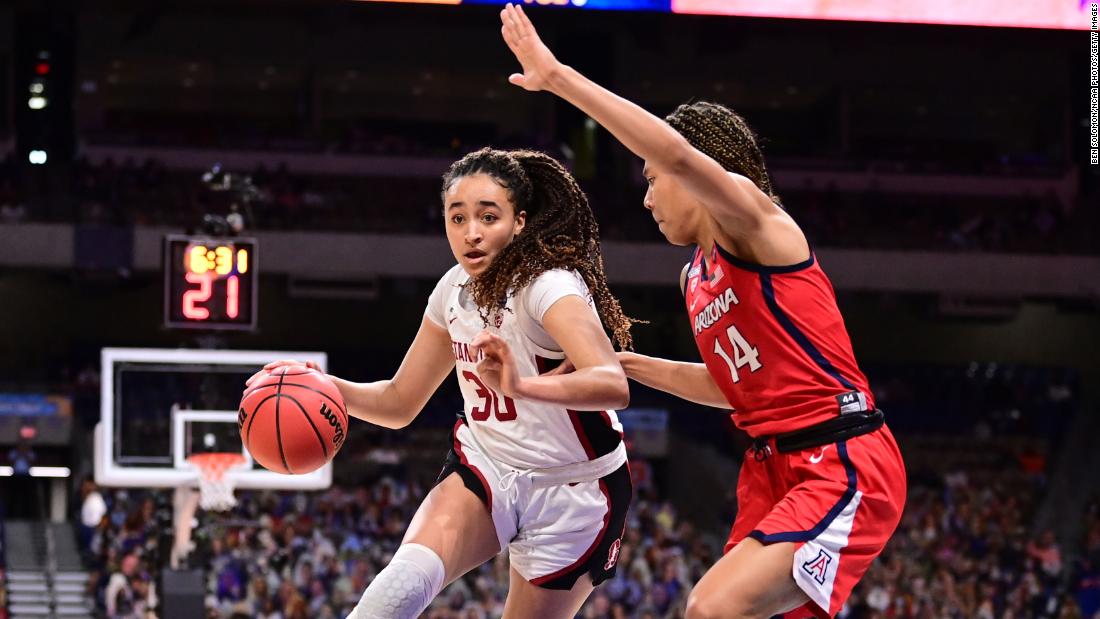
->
xmin=531 ymin=463 xmax=634 ymax=590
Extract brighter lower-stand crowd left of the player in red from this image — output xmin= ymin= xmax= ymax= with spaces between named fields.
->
xmin=83 ymin=457 xmax=722 ymax=619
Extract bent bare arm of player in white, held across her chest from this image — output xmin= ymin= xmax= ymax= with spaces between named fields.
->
xmin=474 ymin=295 xmax=630 ymax=410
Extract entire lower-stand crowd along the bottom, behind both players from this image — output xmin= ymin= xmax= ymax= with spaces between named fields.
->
xmin=83 ymin=439 xmax=1082 ymax=619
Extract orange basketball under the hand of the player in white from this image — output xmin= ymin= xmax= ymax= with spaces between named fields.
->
xmin=237 ymin=365 xmax=348 ymax=475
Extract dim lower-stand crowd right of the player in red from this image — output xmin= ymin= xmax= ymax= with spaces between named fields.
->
xmin=847 ymin=443 xmax=1080 ymax=619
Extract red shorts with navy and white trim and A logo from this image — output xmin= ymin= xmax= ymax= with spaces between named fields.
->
xmin=725 ymin=425 xmax=905 ymax=619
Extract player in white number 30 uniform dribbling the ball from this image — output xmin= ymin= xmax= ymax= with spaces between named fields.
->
xmin=250 ymin=148 xmax=631 ymax=619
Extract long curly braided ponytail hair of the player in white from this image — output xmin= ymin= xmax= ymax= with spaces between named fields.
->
xmin=443 ymin=147 xmax=638 ymax=350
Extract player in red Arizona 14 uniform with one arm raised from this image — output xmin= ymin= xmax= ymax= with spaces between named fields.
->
xmin=501 ymin=4 xmax=905 ymax=619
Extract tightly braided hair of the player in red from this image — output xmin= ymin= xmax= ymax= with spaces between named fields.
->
xmin=664 ymin=101 xmax=782 ymax=206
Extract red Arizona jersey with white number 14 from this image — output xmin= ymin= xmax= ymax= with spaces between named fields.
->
xmin=684 ymin=244 xmax=875 ymax=436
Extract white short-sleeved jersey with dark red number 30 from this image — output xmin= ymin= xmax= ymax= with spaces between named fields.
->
xmin=425 ymin=265 xmax=623 ymax=468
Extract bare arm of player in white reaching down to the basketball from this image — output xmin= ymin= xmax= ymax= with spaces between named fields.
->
xmin=246 ymin=317 xmax=454 ymax=430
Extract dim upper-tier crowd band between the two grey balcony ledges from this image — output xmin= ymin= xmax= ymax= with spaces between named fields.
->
xmin=0 ymin=152 xmax=1097 ymax=253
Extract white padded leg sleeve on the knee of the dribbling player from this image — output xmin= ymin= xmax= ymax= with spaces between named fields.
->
xmin=348 ymin=544 xmax=446 ymax=619
